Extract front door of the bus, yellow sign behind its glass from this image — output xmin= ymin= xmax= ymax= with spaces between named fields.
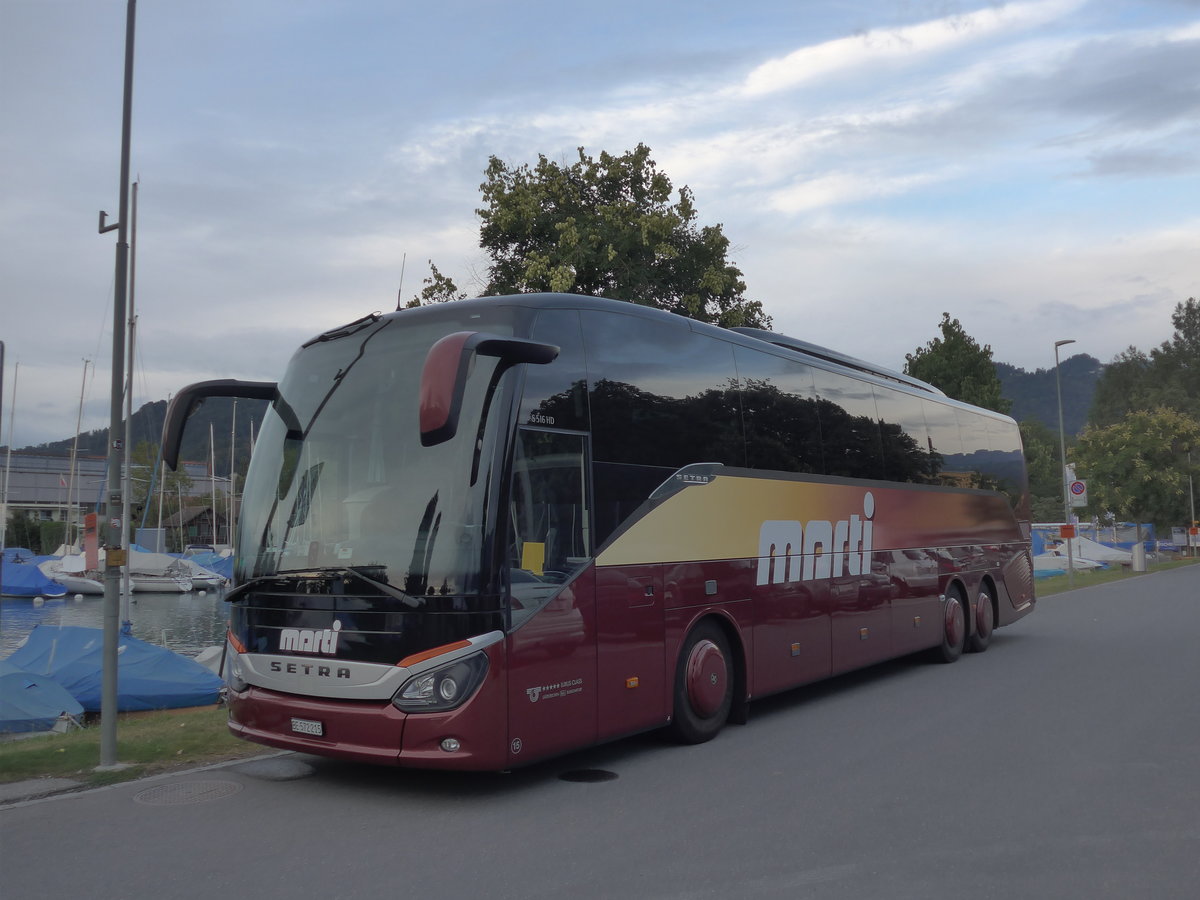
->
xmin=506 ymin=428 xmax=596 ymax=766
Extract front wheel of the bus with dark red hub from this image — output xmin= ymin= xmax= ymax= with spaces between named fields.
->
xmin=671 ymin=622 xmax=733 ymax=744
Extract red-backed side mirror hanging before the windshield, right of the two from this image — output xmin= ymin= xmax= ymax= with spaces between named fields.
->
xmin=420 ymin=331 xmax=558 ymax=446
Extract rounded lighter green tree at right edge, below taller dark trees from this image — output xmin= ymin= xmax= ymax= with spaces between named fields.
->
xmin=1074 ymin=407 xmax=1200 ymax=527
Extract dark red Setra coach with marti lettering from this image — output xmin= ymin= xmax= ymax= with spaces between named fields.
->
xmin=163 ymin=294 xmax=1034 ymax=769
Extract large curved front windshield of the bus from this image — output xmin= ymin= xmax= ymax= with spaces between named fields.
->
xmin=236 ymin=311 xmax=511 ymax=599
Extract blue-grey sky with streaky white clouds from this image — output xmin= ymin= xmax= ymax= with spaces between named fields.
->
xmin=0 ymin=0 xmax=1200 ymax=448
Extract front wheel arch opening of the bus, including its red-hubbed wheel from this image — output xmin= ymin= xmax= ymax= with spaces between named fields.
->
xmin=670 ymin=616 xmax=745 ymax=744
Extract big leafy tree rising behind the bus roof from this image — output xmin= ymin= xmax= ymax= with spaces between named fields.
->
xmin=478 ymin=144 xmax=770 ymax=328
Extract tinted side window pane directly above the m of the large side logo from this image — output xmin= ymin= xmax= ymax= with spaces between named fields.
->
xmin=734 ymin=347 xmax=824 ymax=473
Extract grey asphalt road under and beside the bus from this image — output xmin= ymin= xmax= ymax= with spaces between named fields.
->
xmin=0 ymin=566 xmax=1200 ymax=900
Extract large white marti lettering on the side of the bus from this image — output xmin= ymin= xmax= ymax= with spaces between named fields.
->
xmin=755 ymin=492 xmax=875 ymax=584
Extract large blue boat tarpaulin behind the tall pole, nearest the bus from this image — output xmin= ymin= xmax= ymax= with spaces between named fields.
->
xmin=8 ymin=625 xmax=221 ymax=712
